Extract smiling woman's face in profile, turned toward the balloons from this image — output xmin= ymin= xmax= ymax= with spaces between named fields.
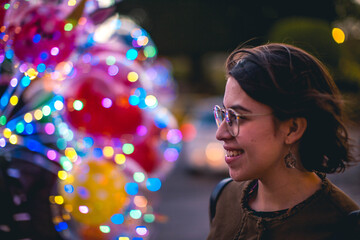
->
xmin=216 ymin=77 xmax=289 ymax=181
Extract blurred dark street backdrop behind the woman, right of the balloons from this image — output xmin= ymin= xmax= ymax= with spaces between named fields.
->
xmin=117 ymin=0 xmax=360 ymax=240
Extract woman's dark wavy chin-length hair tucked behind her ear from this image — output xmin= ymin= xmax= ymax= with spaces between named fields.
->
xmin=226 ymin=43 xmax=354 ymax=173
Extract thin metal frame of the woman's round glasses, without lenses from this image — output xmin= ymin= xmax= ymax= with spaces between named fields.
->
xmin=214 ymin=105 xmax=272 ymax=137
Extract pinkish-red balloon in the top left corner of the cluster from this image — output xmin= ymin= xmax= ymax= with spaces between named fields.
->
xmin=9 ymin=5 xmax=75 ymax=66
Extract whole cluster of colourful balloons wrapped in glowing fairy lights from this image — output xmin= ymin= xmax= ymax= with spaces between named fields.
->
xmin=0 ymin=0 xmax=182 ymax=240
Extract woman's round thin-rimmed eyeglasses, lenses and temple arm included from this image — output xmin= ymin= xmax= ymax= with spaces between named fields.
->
xmin=214 ymin=105 xmax=271 ymax=137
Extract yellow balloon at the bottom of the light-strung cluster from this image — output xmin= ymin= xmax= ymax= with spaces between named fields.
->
xmin=59 ymin=160 xmax=128 ymax=225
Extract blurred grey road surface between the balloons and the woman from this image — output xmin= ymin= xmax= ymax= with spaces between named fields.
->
xmin=151 ymin=159 xmax=222 ymax=240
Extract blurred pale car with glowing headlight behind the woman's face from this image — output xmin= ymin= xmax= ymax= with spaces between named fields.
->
xmin=183 ymin=97 xmax=228 ymax=174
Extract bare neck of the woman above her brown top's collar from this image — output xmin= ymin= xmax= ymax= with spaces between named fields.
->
xmin=249 ymin=169 xmax=321 ymax=212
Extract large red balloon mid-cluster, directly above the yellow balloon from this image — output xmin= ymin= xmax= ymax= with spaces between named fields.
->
xmin=66 ymin=75 xmax=143 ymax=138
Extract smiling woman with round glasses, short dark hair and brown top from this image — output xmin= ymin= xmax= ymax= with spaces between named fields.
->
xmin=208 ymin=44 xmax=359 ymax=240
